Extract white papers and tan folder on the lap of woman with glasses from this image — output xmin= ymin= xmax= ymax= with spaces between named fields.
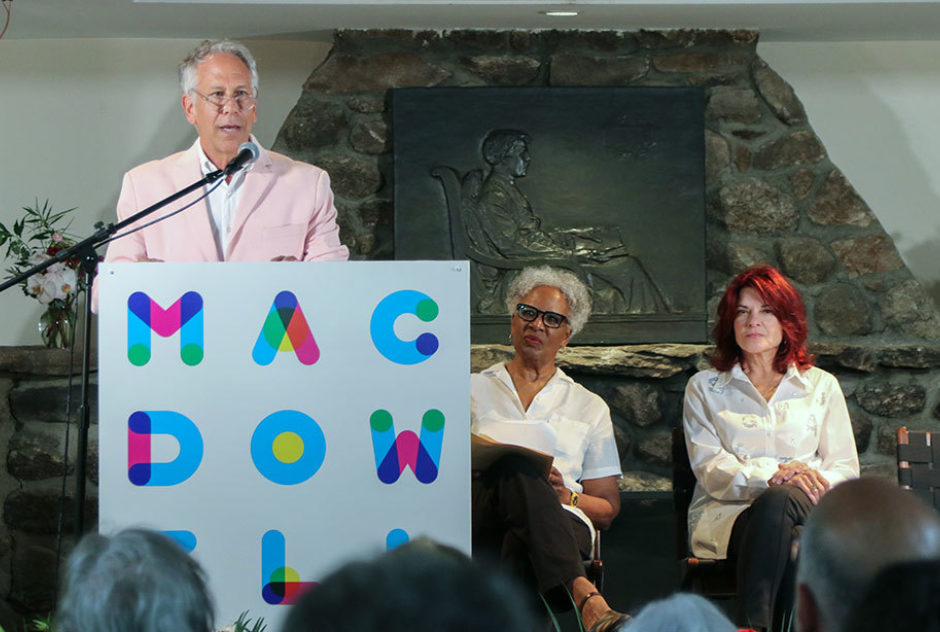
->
xmin=470 ymin=419 xmax=558 ymax=478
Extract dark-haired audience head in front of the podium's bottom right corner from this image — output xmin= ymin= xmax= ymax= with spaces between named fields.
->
xmin=281 ymin=540 xmax=535 ymax=632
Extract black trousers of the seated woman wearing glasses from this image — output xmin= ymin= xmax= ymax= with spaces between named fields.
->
xmin=471 ymin=456 xmax=591 ymax=610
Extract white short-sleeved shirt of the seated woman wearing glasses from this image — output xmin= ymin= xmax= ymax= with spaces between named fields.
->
xmin=470 ymin=363 xmax=621 ymax=535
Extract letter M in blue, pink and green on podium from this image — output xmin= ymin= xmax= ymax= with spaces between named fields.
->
xmin=127 ymin=292 xmax=205 ymax=366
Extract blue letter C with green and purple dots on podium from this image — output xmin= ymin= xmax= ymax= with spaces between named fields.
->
xmin=369 ymin=290 xmax=440 ymax=364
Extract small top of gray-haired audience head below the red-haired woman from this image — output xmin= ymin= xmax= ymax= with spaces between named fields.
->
xmin=623 ymin=593 xmax=737 ymax=632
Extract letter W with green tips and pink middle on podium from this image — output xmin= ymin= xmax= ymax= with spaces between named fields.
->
xmin=369 ymin=409 xmax=444 ymax=485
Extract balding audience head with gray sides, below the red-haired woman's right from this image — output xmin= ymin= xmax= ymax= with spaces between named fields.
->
xmin=797 ymin=478 xmax=940 ymax=632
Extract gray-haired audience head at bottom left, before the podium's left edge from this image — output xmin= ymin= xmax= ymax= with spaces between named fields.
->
xmin=56 ymin=529 xmax=214 ymax=632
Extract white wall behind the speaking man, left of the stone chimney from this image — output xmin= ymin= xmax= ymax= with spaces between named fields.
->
xmin=0 ymin=39 xmax=329 ymax=345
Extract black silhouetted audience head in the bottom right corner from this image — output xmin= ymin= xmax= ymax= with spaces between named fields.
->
xmin=846 ymin=560 xmax=940 ymax=632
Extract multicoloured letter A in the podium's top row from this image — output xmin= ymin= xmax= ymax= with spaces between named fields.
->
xmin=251 ymin=290 xmax=320 ymax=366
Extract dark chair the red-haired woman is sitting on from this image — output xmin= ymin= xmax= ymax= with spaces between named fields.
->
xmin=672 ymin=428 xmax=737 ymax=599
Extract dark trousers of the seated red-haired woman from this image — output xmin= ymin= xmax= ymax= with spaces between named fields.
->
xmin=728 ymin=485 xmax=813 ymax=630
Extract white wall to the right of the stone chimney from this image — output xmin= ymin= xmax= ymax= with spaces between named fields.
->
xmin=758 ymin=41 xmax=940 ymax=299
